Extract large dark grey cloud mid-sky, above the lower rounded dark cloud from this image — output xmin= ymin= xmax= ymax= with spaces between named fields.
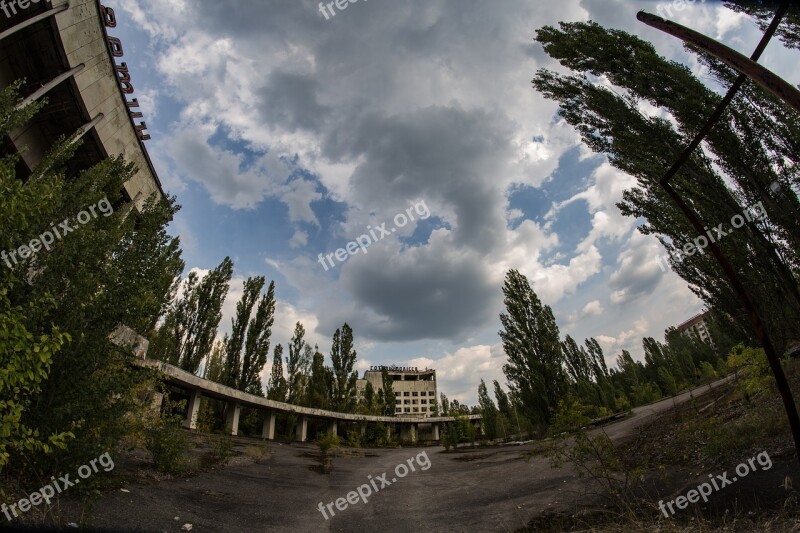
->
xmin=324 ymin=106 xmax=514 ymax=253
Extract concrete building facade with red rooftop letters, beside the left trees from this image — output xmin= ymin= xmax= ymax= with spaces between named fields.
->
xmin=0 ymin=0 xmax=163 ymax=209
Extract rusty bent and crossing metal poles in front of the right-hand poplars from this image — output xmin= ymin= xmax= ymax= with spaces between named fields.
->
xmin=636 ymin=3 xmax=800 ymax=461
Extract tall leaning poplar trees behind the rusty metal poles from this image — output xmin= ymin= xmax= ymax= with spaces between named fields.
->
xmin=533 ymin=19 xmax=800 ymax=354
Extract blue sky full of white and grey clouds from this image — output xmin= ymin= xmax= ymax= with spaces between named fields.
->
xmin=105 ymin=0 xmax=800 ymax=404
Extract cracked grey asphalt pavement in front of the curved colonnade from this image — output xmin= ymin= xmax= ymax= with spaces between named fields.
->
xmin=62 ymin=380 xmax=724 ymax=532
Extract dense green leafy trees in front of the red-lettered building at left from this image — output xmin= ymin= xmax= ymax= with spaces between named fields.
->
xmin=0 ymin=79 xmax=184 ymax=478
